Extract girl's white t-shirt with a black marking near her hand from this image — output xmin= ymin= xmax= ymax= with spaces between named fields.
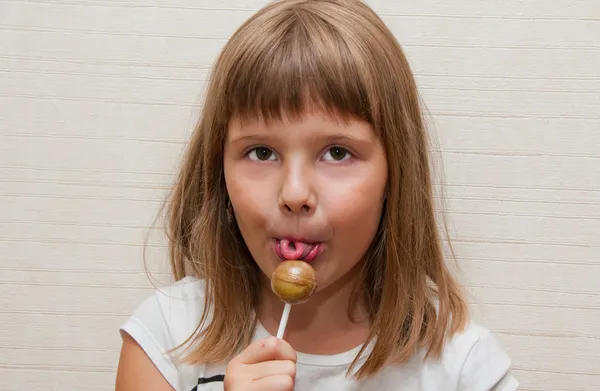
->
xmin=121 ymin=277 xmax=518 ymax=391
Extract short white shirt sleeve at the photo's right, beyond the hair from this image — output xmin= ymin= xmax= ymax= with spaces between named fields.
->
xmin=459 ymin=331 xmax=519 ymax=391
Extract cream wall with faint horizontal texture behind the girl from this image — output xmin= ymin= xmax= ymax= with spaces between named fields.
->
xmin=0 ymin=0 xmax=600 ymax=391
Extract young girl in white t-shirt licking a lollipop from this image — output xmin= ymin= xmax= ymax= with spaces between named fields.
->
xmin=116 ymin=0 xmax=517 ymax=391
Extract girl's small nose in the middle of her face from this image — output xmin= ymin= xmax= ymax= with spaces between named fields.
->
xmin=279 ymin=167 xmax=316 ymax=216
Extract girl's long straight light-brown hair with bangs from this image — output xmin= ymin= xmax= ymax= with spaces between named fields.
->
xmin=167 ymin=0 xmax=468 ymax=378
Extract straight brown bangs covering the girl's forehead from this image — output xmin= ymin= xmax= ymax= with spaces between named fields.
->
xmin=223 ymin=9 xmax=373 ymax=124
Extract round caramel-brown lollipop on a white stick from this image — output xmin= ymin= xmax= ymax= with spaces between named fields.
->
xmin=271 ymin=261 xmax=317 ymax=338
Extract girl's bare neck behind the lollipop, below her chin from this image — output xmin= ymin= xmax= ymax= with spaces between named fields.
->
xmin=257 ymin=264 xmax=370 ymax=354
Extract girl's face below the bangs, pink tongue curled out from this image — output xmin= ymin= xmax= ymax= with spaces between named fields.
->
xmin=224 ymin=112 xmax=387 ymax=290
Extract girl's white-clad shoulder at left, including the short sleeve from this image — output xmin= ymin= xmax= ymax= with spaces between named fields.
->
xmin=120 ymin=277 xmax=205 ymax=390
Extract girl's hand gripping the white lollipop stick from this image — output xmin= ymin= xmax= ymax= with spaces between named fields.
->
xmin=224 ymin=337 xmax=296 ymax=391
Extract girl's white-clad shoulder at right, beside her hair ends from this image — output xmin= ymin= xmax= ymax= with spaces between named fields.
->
xmin=439 ymin=322 xmax=518 ymax=391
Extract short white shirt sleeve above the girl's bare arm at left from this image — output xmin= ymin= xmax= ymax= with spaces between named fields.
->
xmin=120 ymin=292 xmax=180 ymax=390
